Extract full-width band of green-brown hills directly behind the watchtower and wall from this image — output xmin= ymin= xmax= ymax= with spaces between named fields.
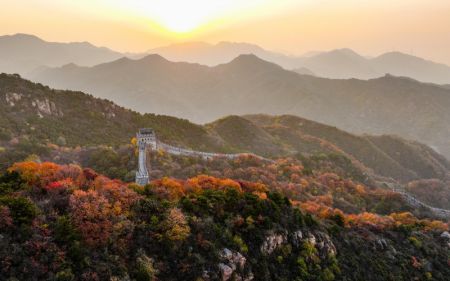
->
xmin=0 ymin=74 xmax=450 ymax=182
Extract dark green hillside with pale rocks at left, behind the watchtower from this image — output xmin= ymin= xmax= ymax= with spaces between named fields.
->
xmin=0 ymin=74 xmax=225 ymax=150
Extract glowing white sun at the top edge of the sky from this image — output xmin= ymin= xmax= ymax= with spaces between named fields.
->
xmin=118 ymin=0 xmax=266 ymax=34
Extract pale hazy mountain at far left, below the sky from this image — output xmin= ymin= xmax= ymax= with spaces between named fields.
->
xmin=0 ymin=34 xmax=123 ymax=76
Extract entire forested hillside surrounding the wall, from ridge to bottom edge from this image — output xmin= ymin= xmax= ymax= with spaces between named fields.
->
xmin=0 ymin=74 xmax=450 ymax=281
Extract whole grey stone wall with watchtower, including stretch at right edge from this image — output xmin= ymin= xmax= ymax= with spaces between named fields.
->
xmin=136 ymin=128 xmax=450 ymax=218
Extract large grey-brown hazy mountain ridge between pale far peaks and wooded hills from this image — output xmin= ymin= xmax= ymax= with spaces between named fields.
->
xmin=33 ymin=55 xmax=450 ymax=158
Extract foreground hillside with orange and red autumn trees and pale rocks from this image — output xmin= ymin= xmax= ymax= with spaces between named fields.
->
xmin=0 ymin=162 xmax=450 ymax=281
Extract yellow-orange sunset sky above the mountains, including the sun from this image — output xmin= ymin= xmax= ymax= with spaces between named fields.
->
xmin=0 ymin=0 xmax=450 ymax=65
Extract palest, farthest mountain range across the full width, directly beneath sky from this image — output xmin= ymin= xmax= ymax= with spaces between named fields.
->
xmin=0 ymin=34 xmax=450 ymax=84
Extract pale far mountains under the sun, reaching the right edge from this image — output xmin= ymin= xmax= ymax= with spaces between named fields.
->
xmin=148 ymin=42 xmax=450 ymax=84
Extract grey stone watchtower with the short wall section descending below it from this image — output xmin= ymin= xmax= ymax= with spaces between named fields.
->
xmin=136 ymin=128 xmax=156 ymax=185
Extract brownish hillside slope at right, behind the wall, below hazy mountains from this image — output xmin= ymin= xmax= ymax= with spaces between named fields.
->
xmin=241 ymin=115 xmax=450 ymax=180
